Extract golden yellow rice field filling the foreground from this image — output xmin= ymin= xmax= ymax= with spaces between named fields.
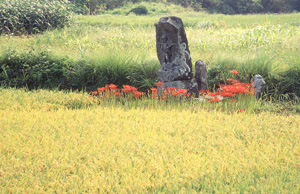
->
xmin=0 ymin=89 xmax=300 ymax=193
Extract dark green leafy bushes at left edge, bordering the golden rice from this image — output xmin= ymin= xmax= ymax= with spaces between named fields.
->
xmin=0 ymin=50 xmax=68 ymax=88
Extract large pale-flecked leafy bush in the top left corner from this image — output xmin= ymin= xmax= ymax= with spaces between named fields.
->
xmin=0 ymin=0 xmax=71 ymax=35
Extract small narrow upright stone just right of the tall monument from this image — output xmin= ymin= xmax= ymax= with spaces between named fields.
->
xmin=195 ymin=60 xmax=208 ymax=91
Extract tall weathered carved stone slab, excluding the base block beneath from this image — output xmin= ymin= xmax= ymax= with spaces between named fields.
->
xmin=155 ymin=16 xmax=193 ymax=82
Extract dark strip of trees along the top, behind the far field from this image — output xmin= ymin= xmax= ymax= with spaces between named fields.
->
xmin=71 ymin=0 xmax=300 ymax=14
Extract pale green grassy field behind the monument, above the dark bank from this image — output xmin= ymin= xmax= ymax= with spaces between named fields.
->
xmin=0 ymin=13 xmax=300 ymax=66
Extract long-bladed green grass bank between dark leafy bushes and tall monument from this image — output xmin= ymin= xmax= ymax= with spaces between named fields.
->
xmin=66 ymin=51 xmax=160 ymax=91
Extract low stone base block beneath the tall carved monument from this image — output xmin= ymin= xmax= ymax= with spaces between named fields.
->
xmin=157 ymin=79 xmax=199 ymax=99
